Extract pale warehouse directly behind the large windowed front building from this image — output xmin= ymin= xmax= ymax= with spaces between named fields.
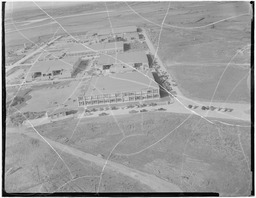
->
xmin=97 ymin=51 xmax=149 ymax=71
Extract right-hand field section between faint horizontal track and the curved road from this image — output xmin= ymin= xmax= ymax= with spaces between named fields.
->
xmin=168 ymin=66 xmax=250 ymax=103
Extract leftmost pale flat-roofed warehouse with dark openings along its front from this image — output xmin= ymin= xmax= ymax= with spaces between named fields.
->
xmin=26 ymin=59 xmax=73 ymax=81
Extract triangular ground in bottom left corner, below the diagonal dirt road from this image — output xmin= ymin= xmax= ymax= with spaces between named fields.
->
xmin=5 ymin=133 xmax=151 ymax=193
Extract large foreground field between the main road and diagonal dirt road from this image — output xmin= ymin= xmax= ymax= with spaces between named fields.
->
xmin=15 ymin=113 xmax=251 ymax=196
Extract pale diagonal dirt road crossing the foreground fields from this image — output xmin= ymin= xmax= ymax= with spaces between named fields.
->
xmin=7 ymin=128 xmax=182 ymax=192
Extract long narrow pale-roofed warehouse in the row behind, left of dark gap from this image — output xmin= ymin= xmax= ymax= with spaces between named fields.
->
xmin=66 ymin=42 xmax=124 ymax=56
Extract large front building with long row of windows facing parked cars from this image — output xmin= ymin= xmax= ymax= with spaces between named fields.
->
xmin=78 ymin=72 xmax=160 ymax=106
